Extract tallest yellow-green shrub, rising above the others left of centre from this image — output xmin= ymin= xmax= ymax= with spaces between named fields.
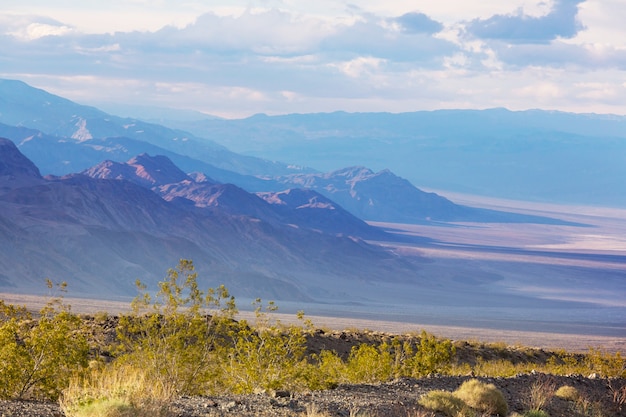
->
xmin=116 ymin=259 xmax=236 ymax=395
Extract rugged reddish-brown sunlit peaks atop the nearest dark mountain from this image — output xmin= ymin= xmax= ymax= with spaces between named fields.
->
xmin=83 ymin=154 xmax=384 ymax=237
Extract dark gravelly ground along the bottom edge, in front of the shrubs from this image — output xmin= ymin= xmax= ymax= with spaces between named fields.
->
xmin=0 ymin=374 xmax=626 ymax=417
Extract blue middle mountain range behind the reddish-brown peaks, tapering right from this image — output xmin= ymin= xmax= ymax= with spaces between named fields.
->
xmin=0 ymin=80 xmax=576 ymax=223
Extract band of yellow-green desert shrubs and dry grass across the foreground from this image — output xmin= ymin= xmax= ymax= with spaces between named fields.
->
xmin=0 ymin=260 xmax=626 ymax=417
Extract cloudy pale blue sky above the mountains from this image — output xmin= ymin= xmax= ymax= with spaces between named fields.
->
xmin=0 ymin=0 xmax=626 ymax=117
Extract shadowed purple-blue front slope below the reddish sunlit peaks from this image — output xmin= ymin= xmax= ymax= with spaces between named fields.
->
xmin=0 ymin=139 xmax=424 ymax=300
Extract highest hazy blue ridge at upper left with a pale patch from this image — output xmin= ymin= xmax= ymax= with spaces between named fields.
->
xmin=0 ymin=80 xmax=300 ymax=175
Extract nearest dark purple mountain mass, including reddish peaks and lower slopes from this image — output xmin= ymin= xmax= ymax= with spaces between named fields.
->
xmin=0 ymin=139 xmax=415 ymax=300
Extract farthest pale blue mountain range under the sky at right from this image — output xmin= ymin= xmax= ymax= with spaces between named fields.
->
xmin=166 ymin=109 xmax=626 ymax=207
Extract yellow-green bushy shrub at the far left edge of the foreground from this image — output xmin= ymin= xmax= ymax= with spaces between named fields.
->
xmin=0 ymin=280 xmax=89 ymax=400
